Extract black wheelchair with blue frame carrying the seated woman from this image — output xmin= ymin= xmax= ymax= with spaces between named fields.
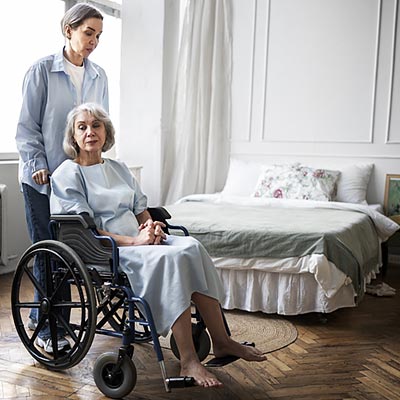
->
xmin=11 ymin=208 xmax=236 ymax=398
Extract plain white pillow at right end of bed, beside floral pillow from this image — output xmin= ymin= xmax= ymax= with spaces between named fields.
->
xmin=336 ymin=164 xmax=374 ymax=204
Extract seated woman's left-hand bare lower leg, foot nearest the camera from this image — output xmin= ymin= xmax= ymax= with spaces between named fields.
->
xmin=172 ymin=308 xmax=222 ymax=387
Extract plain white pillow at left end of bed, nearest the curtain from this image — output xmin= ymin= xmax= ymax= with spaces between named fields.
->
xmin=222 ymin=158 xmax=263 ymax=196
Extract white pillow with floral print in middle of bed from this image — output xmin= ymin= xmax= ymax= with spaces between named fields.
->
xmin=253 ymin=164 xmax=340 ymax=201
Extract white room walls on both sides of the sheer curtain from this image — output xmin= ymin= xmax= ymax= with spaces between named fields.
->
xmin=119 ymin=0 xmax=400 ymax=203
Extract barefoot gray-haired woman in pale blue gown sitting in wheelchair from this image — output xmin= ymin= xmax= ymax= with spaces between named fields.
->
xmin=50 ymin=104 xmax=266 ymax=387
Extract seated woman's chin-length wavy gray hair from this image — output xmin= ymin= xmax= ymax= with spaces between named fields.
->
xmin=63 ymin=103 xmax=115 ymax=159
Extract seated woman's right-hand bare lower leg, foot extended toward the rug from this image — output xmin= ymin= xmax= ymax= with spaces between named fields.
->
xmin=192 ymin=293 xmax=267 ymax=361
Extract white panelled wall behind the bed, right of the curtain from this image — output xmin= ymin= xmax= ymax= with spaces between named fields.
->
xmin=231 ymin=0 xmax=400 ymax=203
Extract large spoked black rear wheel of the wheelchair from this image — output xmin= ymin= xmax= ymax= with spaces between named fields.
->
xmin=11 ymin=240 xmax=96 ymax=370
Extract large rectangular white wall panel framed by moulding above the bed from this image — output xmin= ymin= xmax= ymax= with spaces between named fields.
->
xmin=263 ymin=0 xmax=381 ymax=143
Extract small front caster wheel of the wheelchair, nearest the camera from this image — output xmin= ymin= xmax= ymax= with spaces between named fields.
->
xmin=93 ymin=352 xmax=137 ymax=399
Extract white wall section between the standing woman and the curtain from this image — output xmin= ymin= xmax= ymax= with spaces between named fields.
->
xmin=117 ymin=0 xmax=179 ymax=205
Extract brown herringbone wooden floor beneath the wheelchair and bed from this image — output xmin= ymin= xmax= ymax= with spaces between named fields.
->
xmin=0 ymin=265 xmax=400 ymax=400
